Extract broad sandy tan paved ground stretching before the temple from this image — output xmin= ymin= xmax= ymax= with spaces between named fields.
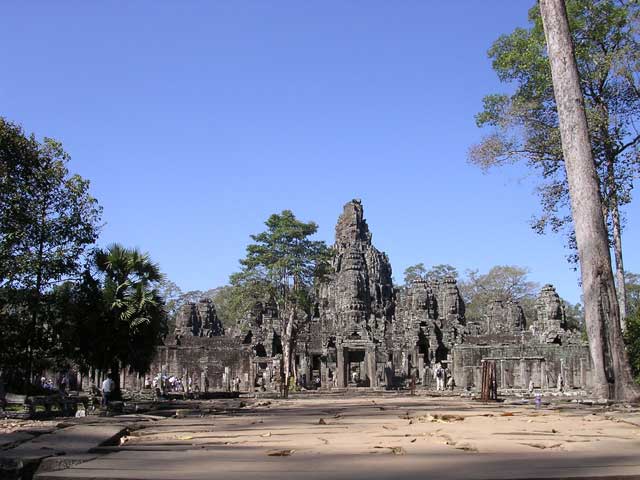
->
xmin=25 ymin=394 xmax=640 ymax=480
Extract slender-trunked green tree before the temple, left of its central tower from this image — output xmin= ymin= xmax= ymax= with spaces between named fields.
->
xmin=231 ymin=210 xmax=328 ymax=396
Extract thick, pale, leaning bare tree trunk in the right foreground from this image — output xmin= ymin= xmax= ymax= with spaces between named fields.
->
xmin=540 ymin=0 xmax=640 ymax=400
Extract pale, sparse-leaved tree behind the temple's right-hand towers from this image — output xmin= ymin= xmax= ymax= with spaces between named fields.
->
xmin=459 ymin=265 xmax=539 ymax=319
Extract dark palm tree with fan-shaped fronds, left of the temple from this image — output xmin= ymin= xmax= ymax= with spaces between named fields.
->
xmin=95 ymin=244 xmax=167 ymax=398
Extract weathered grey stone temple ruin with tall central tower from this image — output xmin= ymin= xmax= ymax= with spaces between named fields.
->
xmin=153 ymin=200 xmax=591 ymax=390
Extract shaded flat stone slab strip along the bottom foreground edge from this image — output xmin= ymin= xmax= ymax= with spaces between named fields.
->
xmin=36 ymin=449 xmax=640 ymax=480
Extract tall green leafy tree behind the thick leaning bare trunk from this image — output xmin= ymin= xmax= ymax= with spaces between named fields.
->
xmin=470 ymin=0 xmax=640 ymax=318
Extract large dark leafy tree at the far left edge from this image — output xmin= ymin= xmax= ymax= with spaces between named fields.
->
xmin=0 ymin=118 xmax=101 ymax=381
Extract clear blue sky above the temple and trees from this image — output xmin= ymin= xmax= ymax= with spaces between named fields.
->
xmin=0 ymin=0 xmax=640 ymax=301
